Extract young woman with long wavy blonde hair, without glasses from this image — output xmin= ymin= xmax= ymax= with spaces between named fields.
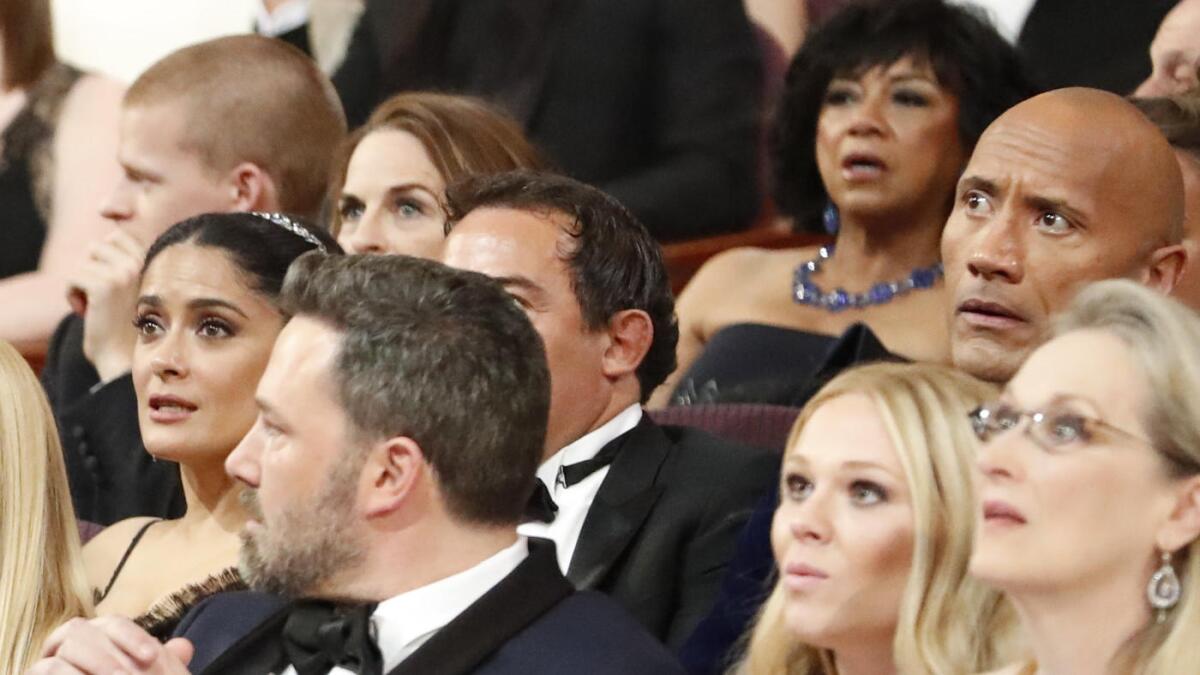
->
xmin=736 ymin=364 xmax=1012 ymax=675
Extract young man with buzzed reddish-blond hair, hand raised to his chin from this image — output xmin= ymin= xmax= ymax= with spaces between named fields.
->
xmin=42 ymin=36 xmax=346 ymax=525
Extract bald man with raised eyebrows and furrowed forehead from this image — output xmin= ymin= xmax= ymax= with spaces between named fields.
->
xmin=942 ymin=88 xmax=1187 ymax=382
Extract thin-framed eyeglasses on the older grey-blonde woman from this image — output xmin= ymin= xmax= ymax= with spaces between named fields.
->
xmin=967 ymin=402 xmax=1153 ymax=452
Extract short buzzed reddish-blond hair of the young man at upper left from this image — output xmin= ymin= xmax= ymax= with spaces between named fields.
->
xmin=125 ymin=35 xmax=346 ymax=219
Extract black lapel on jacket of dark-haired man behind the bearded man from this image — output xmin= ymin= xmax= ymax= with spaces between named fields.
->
xmin=566 ymin=413 xmax=671 ymax=589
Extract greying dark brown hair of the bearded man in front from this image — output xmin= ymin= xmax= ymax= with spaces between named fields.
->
xmin=283 ymin=256 xmax=550 ymax=525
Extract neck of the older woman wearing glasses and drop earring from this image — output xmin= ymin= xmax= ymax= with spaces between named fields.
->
xmin=1010 ymin=577 xmax=1151 ymax=675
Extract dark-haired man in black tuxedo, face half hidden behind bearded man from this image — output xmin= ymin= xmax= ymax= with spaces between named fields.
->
xmin=444 ymin=172 xmax=779 ymax=647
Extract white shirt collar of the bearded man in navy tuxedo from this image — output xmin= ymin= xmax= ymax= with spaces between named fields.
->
xmin=283 ymin=537 xmax=529 ymax=675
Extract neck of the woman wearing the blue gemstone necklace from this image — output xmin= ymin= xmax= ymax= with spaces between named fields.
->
xmin=822 ymin=204 xmax=946 ymax=287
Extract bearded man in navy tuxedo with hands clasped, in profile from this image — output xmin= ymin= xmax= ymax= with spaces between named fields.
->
xmin=34 ymin=255 xmax=680 ymax=675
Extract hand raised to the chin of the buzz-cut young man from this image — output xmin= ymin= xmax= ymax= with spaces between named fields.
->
xmin=68 ymin=229 xmax=146 ymax=382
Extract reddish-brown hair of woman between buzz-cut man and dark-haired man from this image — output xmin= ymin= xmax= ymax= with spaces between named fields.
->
xmin=330 ymin=91 xmax=548 ymax=237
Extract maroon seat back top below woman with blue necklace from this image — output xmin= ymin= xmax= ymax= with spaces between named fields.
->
xmin=649 ymin=404 xmax=800 ymax=453
